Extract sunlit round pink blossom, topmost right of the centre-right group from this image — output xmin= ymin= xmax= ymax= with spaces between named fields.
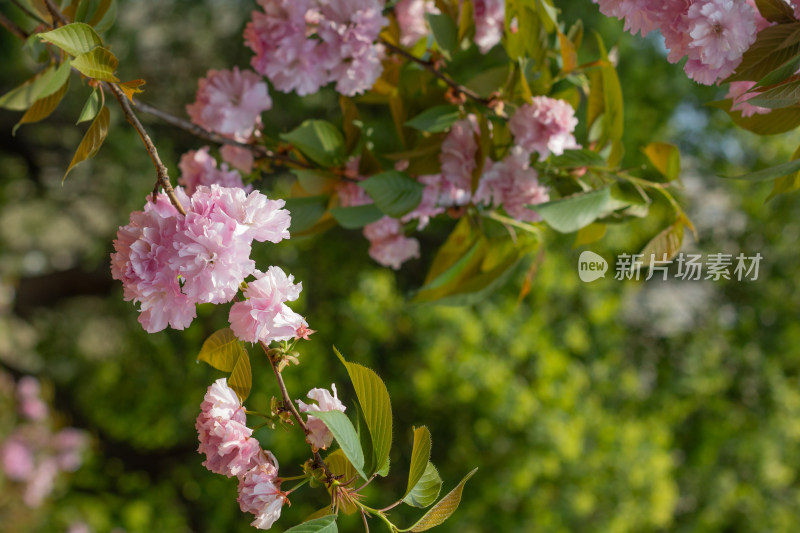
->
xmin=508 ymin=96 xmax=580 ymax=159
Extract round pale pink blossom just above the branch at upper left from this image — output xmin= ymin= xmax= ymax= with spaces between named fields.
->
xmin=186 ymin=67 xmax=272 ymax=142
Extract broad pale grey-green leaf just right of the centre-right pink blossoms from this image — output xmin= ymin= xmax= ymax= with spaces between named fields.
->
xmin=533 ymin=187 xmax=626 ymax=233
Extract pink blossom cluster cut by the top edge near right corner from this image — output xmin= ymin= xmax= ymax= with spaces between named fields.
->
xmin=593 ymin=0 xmax=769 ymax=85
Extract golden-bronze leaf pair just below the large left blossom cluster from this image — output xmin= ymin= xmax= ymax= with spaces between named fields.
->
xmin=196 ymin=326 xmax=253 ymax=403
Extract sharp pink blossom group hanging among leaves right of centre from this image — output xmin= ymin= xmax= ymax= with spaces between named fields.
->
xmin=337 ymin=96 xmax=580 ymax=270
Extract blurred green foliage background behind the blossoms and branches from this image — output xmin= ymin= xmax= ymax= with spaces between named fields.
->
xmin=0 ymin=0 xmax=800 ymax=533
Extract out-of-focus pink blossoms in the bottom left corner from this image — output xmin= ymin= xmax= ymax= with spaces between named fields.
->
xmin=0 ymin=374 xmax=89 ymax=508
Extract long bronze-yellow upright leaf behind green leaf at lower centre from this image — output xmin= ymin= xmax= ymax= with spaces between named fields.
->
xmin=333 ymin=347 xmax=392 ymax=478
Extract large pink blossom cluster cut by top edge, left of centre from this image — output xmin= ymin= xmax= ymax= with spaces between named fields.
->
xmin=244 ymin=0 xmax=388 ymax=96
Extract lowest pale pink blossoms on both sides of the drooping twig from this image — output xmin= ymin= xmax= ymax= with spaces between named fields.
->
xmin=195 ymin=378 xmax=345 ymax=529
